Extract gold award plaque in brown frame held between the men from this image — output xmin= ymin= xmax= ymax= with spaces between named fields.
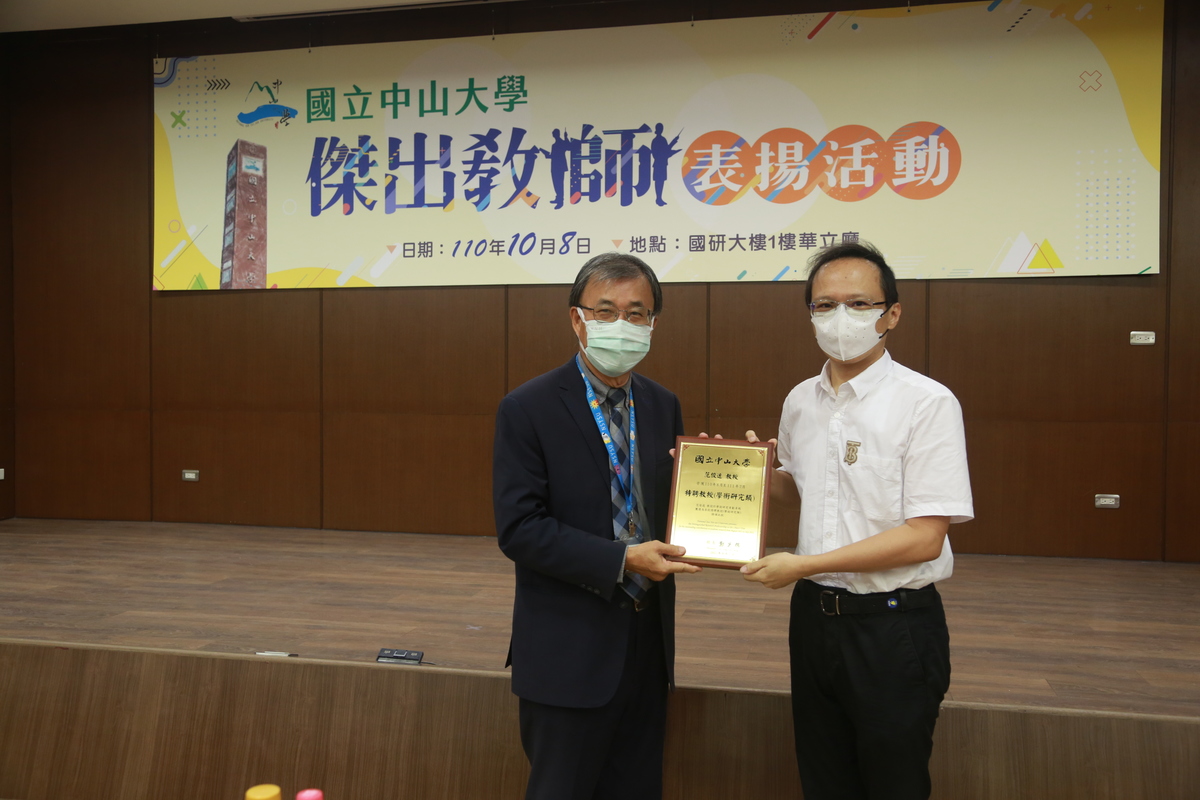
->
xmin=667 ymin=437 xmax=775 ymax=570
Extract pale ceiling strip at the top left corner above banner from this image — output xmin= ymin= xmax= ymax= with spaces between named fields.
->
xmin=0 ymin=0 xmax=451 ymax=32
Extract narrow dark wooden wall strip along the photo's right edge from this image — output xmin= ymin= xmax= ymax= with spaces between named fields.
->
xmin=1165 ymin=2 xmax=1200 ymax=561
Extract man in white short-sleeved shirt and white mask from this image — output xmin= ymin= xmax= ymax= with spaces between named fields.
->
xmin=742 ymin=243 xmax=973 ymax=800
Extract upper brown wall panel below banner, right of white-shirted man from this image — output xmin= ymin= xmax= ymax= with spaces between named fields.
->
xmin=930 ymin=283 xmax=1165 ymax=422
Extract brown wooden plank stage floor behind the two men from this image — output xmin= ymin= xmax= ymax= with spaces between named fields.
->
xmin=0 ymin=519 xmax=1200 ymax=718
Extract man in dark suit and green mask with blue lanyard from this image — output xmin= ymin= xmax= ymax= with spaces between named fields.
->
xmin=492 ymin=253 xmax=700 ymax=800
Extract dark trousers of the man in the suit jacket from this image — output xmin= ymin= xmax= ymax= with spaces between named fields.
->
xmin=521 ymin=589 xmax=667 ymax=800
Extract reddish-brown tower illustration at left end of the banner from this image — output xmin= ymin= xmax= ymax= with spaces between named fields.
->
xmin=221 ymin=139 xmax=266 ymax=289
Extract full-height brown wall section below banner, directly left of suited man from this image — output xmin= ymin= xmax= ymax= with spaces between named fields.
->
xmin=323 ymin=287 xmax=505 ymax=535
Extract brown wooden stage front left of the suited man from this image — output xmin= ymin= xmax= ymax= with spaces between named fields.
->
xmin=0 ymin=643 xmax=528 ymax=800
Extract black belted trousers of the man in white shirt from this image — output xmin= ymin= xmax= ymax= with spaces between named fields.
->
xmin=788 ymin=581 xmax=950 ymax=800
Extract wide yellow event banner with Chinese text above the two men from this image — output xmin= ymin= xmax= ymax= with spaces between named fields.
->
xmin=152 ymin=0 xmax=1163 ymax=289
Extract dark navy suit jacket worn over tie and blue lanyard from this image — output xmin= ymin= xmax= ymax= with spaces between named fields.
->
xmin=492 ymin=359 xmax=683 ymax=708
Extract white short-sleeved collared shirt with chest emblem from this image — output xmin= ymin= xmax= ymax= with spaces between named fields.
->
xmin=779 ymin=351 xmax=974 ymax=594
